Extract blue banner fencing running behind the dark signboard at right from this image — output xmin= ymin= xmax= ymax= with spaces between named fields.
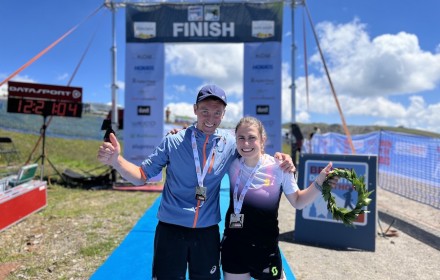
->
xmin=304 ymin=131 xmax=440 ymax=186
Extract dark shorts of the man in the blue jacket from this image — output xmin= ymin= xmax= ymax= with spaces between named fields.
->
xmin=153 ymin=222 xmax=220 ymax=280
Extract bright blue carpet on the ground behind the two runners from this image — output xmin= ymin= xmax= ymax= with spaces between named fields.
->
xmin=90 ymin=176 xmax=296 ymax=280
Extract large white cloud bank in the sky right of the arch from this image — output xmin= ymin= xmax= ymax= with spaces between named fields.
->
xmin=296 ymin=20 xmax=440 ymax=132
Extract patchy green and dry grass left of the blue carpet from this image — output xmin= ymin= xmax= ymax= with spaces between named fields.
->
xmin=0 ymin=130 xmax=159 ymax=279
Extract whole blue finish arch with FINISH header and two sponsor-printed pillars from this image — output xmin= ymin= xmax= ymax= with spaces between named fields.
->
xmin=123 ymin=1 xmax=283 ymax=164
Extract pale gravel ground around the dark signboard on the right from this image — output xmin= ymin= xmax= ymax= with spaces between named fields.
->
xmin=279 ymin=188 xmax=440 ymax=280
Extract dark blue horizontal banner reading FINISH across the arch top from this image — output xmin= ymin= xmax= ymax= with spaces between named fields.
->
xmin=125 ymin=1 xmax=283 ymax=43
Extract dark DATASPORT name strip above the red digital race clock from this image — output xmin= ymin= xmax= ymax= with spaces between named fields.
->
xmin=8 ymin=81 xmax=82 ymax=103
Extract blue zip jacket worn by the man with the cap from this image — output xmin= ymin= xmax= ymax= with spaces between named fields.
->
xmin=141 ymin=125 xmax=237 ymax=228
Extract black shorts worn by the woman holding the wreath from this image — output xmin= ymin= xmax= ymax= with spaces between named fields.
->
xmin=221 ymin=236 xmax=283 ymax=279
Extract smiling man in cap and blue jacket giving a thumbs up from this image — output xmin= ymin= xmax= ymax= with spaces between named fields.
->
xmin=98 ymin=85 xmax=294 ymax=279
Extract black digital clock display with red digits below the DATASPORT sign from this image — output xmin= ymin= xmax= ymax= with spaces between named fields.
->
xmin=8 ymin=98 xmax=82 ymax=118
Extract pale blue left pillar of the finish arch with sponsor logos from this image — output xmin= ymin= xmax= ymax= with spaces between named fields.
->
xmin=124 ymin=43 xmax=165 ymax=184
